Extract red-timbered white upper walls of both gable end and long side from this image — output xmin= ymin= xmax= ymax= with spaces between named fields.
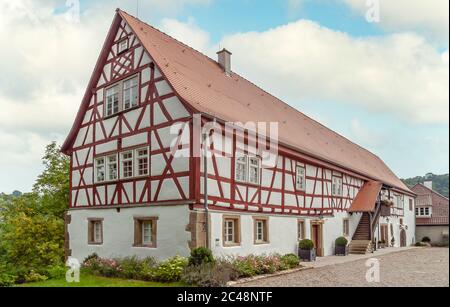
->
xmin=63 ymin=10 xmax=414 ymax=216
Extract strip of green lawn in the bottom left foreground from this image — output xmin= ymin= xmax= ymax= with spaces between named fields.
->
xmin=18 ymin=275 xmax=186 ymax=288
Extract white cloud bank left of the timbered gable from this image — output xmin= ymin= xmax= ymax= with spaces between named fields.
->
xmin=0 ymin=0 xmax=209 ymax=192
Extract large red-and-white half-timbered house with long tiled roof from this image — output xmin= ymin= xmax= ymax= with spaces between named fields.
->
xmin=62 ymin=10 xmax=415 ymax=260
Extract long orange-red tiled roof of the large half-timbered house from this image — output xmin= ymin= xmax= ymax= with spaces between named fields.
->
xmin=63 ymin=10 xmax=412 ymax=193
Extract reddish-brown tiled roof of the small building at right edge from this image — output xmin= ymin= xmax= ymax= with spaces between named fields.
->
xmin=412 ymin=183 xmax=449 ymax=226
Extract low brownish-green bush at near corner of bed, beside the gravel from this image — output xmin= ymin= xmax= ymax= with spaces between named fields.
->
xmin=181 ymin=261 xmax=239 ymax=287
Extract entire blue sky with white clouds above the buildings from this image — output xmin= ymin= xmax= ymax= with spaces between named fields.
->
xmin=0 ymin=0 xmax=449 ymax=193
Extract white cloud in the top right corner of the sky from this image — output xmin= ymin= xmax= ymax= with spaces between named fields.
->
xmin=340 ymin=0 xmax=449 ymax=44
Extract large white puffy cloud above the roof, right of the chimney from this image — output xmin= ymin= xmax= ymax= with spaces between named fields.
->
xmin=217 ymin=20 xmax=449 ymax=123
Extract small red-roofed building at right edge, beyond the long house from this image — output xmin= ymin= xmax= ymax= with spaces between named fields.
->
xmin=412 ymin=181 xmax=449 ymax=245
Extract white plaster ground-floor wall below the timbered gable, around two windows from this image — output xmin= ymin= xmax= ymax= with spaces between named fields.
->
xmin=69 ymin=206 xmax=191 ymax=261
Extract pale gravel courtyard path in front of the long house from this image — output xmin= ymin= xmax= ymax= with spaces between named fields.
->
xmin=239 ymin=248 xmax=449 ymax=287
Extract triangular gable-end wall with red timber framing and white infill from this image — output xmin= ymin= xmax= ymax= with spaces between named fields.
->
xmin=63 ymin=15 xmax=195 ymax=209
